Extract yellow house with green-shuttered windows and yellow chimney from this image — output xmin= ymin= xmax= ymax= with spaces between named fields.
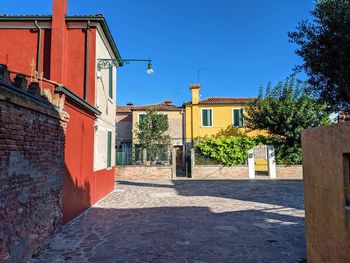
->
xmin=185 ymin=84 xmax=261 ymax=143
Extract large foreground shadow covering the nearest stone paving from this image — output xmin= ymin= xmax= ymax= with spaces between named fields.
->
xmin=35 ymin=206 xmax=306 ymax=262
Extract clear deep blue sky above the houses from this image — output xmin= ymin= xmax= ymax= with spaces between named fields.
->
xmin=0 ymin=0 xmax=313 ymax=105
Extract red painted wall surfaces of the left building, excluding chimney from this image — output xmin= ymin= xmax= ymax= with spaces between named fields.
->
xmin=0 ymin=23 xmax=114 ymax=223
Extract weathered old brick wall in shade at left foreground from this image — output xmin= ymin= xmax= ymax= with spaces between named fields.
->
xmin=0 ymin=65 xmax=68 ymax=262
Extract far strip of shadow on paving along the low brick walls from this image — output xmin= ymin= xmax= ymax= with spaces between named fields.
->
xmin=117 ymin=180 xmax=304 ymax=210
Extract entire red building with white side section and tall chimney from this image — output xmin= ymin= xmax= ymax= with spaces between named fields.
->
xmin=0 ymin=0 xmax=122 ymax=222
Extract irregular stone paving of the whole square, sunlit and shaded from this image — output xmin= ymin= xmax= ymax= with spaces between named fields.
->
xmin=34 ymin=180 xmax=306 ymax=263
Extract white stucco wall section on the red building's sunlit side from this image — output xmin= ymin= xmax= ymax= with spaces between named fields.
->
xmin=94 ymin=29 xmax=117 ymax=171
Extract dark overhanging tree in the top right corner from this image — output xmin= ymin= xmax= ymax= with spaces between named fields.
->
xmin=289 ymin=0 xmax=350 ymax=112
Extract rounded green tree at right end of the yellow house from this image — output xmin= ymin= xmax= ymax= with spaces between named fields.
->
xmin=245 ymin=77 xmax=330 ymax=163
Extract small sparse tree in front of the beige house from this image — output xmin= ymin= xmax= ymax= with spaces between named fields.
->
xmin=137 ymin=110 xmax=170 ymax=161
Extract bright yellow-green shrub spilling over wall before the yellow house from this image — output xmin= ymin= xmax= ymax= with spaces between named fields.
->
xmin=195 ymin=136 xmax=255 ymax=166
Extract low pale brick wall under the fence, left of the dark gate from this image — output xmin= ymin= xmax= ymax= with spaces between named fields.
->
xmin=115 ymin=166 xmax=172 ymax=180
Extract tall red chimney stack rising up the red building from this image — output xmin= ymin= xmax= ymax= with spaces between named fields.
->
xmin=50 ymin=0 xmax=68 ymax=84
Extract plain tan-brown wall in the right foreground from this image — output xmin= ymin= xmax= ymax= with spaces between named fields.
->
xmin=302 ymin=122 xmax=350 ymax=263
